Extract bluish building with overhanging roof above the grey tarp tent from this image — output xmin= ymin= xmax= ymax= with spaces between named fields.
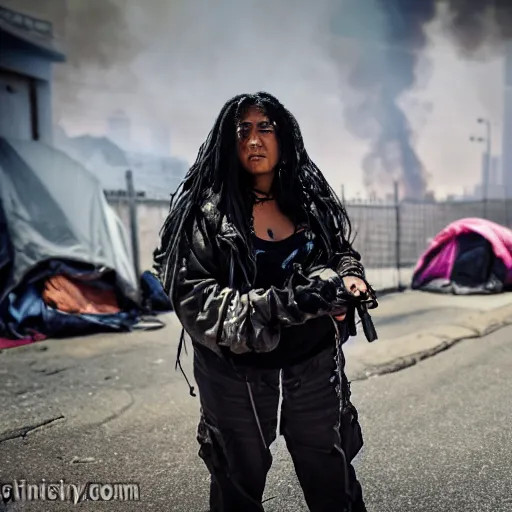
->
xmin=0 ymin=4 xmax=65 ymax=144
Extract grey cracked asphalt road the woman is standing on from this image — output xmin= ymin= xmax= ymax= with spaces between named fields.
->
xmin=0 ymin=318 xmax=512 ymax=512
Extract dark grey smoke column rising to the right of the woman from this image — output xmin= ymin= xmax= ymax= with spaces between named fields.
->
xmin=332 ymin=0 xmax=436 ymax=199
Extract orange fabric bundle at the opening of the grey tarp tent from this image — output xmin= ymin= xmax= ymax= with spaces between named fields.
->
xmin=42 ymin=275 xmax=121 ymax=315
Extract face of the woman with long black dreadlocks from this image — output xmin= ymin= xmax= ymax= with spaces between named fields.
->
xmin=237 ymin=107 xmax=279 ymax=175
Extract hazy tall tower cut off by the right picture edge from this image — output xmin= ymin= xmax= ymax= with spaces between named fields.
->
xmin=501 ymin=41 xmax=512 ymax=198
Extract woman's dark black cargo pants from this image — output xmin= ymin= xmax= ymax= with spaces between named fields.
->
xmin=194 ymin=342 xmax=366 ymax=512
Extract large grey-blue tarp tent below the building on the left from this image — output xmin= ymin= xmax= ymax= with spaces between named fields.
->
xmin=0 ymin=138 xmax=148 ymax=337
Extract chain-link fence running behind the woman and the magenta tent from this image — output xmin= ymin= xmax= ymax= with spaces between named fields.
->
xmin=108 ymin=178 xmax=512 ymax=290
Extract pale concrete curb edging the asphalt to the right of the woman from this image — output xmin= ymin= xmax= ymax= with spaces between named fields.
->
xmin=352 ymin=304 xmax=512 ymax=381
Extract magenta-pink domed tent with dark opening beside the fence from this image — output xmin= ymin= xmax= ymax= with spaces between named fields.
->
xmin=412 ymin=218 xmax=512 ymax=295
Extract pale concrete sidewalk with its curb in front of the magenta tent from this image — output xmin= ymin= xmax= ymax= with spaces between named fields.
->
xmin=345 ymin=290 xmax=512 ymax=380
